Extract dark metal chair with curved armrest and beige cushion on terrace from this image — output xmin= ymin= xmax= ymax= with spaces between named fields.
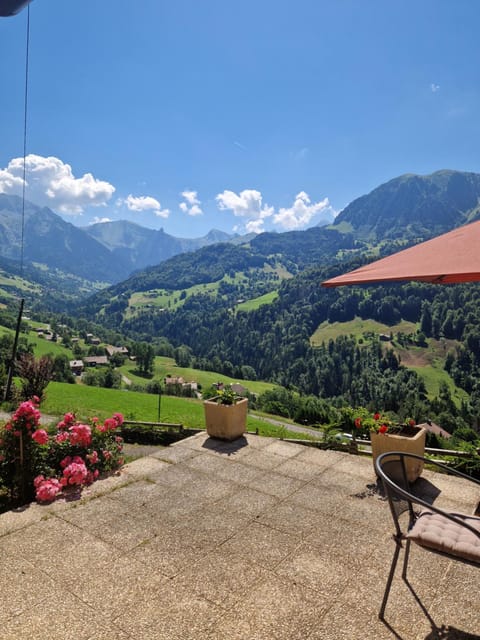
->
xmin=375 ymin=451 xmax=480 ymax=620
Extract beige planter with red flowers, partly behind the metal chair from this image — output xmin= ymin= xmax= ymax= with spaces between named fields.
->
xmin=354 ymin=413 xmax=427 ymax=482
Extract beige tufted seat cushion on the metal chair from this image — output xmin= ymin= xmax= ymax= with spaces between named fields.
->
xmin=407 ymin=509 xmax=480 ymax=564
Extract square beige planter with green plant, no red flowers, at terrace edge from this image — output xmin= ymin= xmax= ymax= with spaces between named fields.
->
xmin=203 ymin=385 xmax=248 ymax=440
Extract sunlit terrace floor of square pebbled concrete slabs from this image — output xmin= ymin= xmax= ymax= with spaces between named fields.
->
xmin=0 ymin=434 xmax=480 ymax=640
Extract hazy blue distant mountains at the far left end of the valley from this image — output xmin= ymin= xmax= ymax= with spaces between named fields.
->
xmin=0 ymin=194 xmax=251 ymax=284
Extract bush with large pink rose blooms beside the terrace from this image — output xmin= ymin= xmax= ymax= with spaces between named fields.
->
xmin=0 ymin=398 xmax=123 ymax=505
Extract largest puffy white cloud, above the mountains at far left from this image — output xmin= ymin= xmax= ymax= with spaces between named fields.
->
xmin=0 ymin=154 xmax=115 ymax=215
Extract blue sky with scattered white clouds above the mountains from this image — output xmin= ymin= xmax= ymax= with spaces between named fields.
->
xmin=0 ymin=0 xmax=480 ymax=237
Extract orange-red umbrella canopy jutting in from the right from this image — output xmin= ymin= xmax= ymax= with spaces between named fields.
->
xmin=322 ymin=221 xmax=480 ymax=287
